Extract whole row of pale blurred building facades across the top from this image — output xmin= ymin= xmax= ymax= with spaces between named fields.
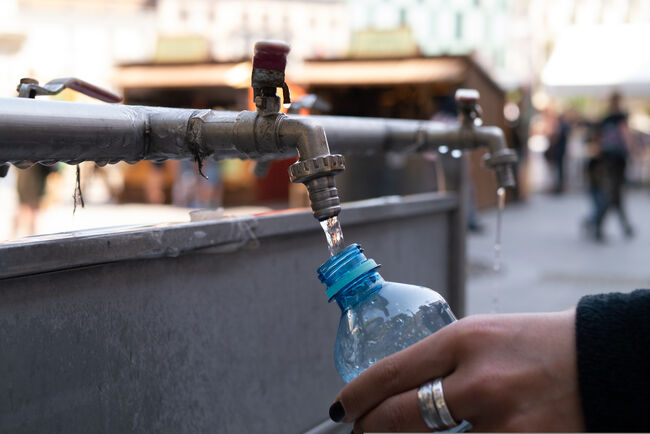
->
xmin=0 ymin=0 xmax=650 ymax=95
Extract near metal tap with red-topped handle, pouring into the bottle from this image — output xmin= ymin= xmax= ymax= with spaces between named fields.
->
xmin=249 ymin=41 xmax=345 ymax=220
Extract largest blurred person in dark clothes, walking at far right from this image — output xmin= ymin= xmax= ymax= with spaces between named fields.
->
xmin=588 ymin=93 xmax=634 ymax=241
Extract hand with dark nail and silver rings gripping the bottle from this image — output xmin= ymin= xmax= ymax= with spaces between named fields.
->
xmin=330 ymin=309 xmax=585 ymax=434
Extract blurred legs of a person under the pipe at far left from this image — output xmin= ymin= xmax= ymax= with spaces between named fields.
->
xmin=12 ymin=164 xmax=52 ymax=238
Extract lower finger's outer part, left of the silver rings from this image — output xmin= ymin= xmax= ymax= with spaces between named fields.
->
xmin=354 ymin=389 xmax=431 ymax=434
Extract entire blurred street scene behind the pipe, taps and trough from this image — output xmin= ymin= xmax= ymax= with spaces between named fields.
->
xmin=0 ymin=0 xmax=650 ymax=313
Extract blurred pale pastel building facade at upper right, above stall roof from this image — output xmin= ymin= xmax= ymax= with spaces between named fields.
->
xmin=348 ymin=0 xmax=650 ymax=88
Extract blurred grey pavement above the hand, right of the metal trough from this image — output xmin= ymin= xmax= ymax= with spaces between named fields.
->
xmin=467 ymin=190 xmax=650 ymax=314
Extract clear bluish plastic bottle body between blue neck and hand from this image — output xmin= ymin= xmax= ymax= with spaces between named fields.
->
xmin=334 ymin=272 xmax=456 ymax=383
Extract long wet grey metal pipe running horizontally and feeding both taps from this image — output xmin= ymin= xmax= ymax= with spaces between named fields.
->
xmin=0 ymin=98 xmax=505 ymax=164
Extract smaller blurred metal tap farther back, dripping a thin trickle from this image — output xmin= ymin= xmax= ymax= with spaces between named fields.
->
xmin=455 ymin=89 xmax=517 ymax=188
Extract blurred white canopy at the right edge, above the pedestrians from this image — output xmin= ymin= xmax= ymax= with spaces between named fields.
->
xmin=542 ymin=24 xmax=650 ymax=98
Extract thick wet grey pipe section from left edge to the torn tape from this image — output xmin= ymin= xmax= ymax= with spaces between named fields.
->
xmin=0 ymin=98 xmax=201 ymax=164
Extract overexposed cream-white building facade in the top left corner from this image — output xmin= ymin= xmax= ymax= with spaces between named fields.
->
xmin=0 ymin=0 xmax=156 ymax=96
